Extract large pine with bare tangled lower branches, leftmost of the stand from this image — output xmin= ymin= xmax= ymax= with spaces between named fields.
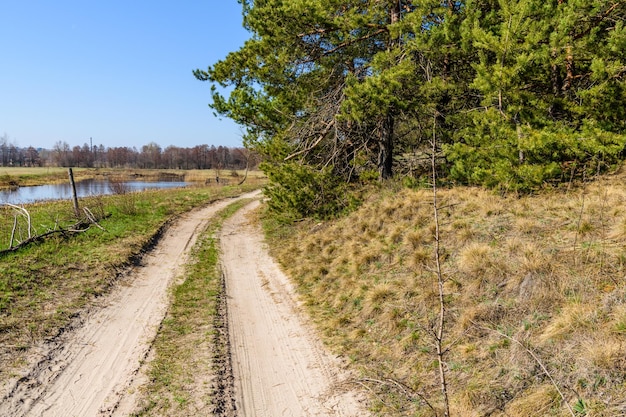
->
xmin=194 ymin=0 xmax=420 ymax=218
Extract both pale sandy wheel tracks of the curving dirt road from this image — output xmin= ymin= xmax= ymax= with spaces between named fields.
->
xmin=0 ymin=194 xmax=365 ymax=417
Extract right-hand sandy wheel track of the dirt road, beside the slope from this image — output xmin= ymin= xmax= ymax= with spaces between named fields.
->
xmin=220 ymin=201 xmax=368 ymax=417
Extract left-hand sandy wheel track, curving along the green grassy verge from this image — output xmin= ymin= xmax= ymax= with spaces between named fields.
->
xmin=0 ymin=193 xmax=258 ymax=417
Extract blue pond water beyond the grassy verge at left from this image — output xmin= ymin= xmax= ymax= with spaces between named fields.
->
xmin=0 ymin=180 xmax=189 ymax=204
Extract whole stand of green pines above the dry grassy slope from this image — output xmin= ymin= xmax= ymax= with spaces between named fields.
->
xmin=194 ymin=0 xmax=626 ymax=214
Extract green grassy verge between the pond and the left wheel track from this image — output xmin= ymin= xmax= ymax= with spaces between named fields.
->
xmin=0 ymin=172 xmax=262 ymax=381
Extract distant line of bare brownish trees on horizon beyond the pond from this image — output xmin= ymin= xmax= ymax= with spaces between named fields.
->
xmin=0 ymin=134 xmax=259 ymax=169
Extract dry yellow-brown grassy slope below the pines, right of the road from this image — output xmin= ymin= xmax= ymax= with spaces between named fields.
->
xmin=269 ymin=173 xmax=626 ymax=416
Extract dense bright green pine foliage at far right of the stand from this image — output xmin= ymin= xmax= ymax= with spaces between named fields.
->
xmin=446 ymin=0 xmax=626 ymax=189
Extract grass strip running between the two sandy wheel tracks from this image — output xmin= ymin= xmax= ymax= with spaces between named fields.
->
xmin=133 ymin=200 xmax=248 ymax=417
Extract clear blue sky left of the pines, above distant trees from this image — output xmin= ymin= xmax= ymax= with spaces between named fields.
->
xmin=0 ymin=0 xmax=249 ymax=149
